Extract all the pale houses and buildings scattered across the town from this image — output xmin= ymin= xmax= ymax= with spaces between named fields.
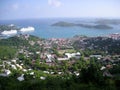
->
xmin=0 ymin=34 xmax=120 ymax=81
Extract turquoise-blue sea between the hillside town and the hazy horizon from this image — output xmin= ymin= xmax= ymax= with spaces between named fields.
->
xmin=0 ymin=19 xmax=120 ymax=38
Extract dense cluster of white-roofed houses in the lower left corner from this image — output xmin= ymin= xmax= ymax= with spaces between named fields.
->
xmin=0 ymin=60 xmax=45 ymax=81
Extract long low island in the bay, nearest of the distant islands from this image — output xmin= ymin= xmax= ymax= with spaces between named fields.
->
xmin=52 ymin=21 xmax=113 ymax=29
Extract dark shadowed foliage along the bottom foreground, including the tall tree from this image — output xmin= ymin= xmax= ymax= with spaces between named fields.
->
xmin=0 ymin=59 xmax=120 ymax=90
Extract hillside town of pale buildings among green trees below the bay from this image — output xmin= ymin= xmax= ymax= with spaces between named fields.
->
xmin=0 ymin=34 xmax=120 ymax=89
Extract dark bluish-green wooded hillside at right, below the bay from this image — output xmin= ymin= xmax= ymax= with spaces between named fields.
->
xmin=74 ymin=37 xmax=120 ymax=55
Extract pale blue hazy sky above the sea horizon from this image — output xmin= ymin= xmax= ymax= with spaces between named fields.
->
xmin=0 ymin=0 xmax=120 ymax=20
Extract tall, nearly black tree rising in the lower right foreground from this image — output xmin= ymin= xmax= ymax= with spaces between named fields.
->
xmin=80 ymin=59 xmax=104 ymax=85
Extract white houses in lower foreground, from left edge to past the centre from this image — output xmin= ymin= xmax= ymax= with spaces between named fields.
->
xmin=0 ymin=57 xmax=79 ymax=81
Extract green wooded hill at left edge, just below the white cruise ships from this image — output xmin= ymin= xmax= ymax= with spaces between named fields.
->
xmin=0 ymin=35 xmax=40 ymax=60
